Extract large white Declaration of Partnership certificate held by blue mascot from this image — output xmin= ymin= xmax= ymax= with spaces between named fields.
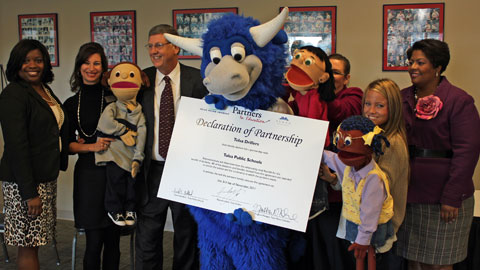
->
xmin=158 ymin=97 xmax=328 ymax=232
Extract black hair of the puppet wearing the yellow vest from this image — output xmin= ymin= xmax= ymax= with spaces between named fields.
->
xmin=340 ymin=115 xmax=390 ymax=155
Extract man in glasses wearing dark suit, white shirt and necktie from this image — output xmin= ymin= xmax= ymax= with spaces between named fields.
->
xmin=135 ymin=24 xmax=207 ymax=270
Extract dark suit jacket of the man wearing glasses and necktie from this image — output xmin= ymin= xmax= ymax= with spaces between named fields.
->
xmin=137 ymin=64 xmax=208 ymax=204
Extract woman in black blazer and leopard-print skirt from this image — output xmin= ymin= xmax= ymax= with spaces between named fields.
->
xmin=0 ymin=40 xmax=68 ymax=269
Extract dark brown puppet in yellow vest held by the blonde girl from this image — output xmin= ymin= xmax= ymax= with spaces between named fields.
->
xmin=323 ymin=116 xmax=394 ymax=270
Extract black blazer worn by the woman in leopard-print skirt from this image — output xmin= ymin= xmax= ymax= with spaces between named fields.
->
xmin=0 ymin=81 xmax=68 ymax=200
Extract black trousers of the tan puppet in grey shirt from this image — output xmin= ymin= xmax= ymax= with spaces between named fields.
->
xmin=105 ymin=162 xmax=135 ymax=214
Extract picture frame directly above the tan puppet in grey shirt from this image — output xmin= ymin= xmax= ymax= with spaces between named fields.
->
xmin=90 ymin=10 xmax=137 ymax=68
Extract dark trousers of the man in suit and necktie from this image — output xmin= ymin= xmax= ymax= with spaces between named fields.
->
xmin=135 ymin=163 xmax=199 ymax=270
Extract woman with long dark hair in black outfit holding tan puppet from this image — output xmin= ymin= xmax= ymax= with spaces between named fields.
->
xmin=64 ymin=42 xmax=120 ymax=270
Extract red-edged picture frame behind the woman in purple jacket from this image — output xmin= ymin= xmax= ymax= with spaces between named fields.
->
xmin=382 ymin=3 xmax=445 ymax=71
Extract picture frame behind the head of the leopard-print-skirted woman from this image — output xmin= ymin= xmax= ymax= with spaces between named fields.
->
xmin=18 ymin=13 xmax=60 ymax=67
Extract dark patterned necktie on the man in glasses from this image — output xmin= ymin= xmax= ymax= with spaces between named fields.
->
xmin=158 ymin=76 xmax=175 ymax=159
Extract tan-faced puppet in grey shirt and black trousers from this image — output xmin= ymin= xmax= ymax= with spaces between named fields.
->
xmin=95 ymin=62 xmax=149 ymax=226
